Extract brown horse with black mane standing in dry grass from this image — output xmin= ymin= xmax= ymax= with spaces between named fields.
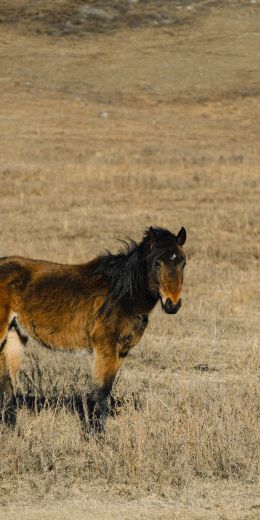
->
xmin=0 ymin=227 xmax=186 ymax=432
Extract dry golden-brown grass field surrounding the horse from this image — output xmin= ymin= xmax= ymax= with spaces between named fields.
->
xmin=0 ymin=0 xmax=260 ymax=520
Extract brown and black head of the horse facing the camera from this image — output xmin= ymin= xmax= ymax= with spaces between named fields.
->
xmin=145 ymin=227 xmax=186 ymax=314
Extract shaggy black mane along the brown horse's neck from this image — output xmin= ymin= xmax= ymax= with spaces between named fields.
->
xmin=91 ymin=228 xmax=176 ymax=315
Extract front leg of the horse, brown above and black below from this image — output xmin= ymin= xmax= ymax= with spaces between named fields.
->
xmin=88 ymin=341 xmax=120 ymax=433
